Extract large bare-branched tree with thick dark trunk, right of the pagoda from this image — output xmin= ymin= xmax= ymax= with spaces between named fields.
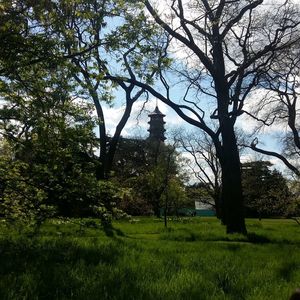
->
xmin=106 ymin=0 xmax=299 ymax=233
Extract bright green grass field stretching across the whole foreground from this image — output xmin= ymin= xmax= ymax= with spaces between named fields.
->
xmin=0 ymin=218 xmax=300 ymax=300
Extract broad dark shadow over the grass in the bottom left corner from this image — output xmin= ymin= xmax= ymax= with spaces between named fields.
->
xmin=0 ymin=237 xmax=149 ymax=299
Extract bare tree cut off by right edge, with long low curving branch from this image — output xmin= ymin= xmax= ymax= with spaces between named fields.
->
xmin=250 ymin=43 xmax=300 ymax=177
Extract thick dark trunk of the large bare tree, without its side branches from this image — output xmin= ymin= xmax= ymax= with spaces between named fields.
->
xmin=213 ymin=22 xmax=247 ymax=234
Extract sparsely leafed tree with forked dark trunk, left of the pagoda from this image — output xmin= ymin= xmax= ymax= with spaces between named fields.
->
xmin=0 ymin=0 xmax=169 ymax=179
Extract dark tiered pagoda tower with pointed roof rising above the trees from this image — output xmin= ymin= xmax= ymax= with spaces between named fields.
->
xmin=148 ymin=105 xmax=166 ymax=142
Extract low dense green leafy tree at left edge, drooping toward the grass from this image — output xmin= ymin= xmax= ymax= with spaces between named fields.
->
xmin=0 ymin=99 xmax=104 ymax=227
